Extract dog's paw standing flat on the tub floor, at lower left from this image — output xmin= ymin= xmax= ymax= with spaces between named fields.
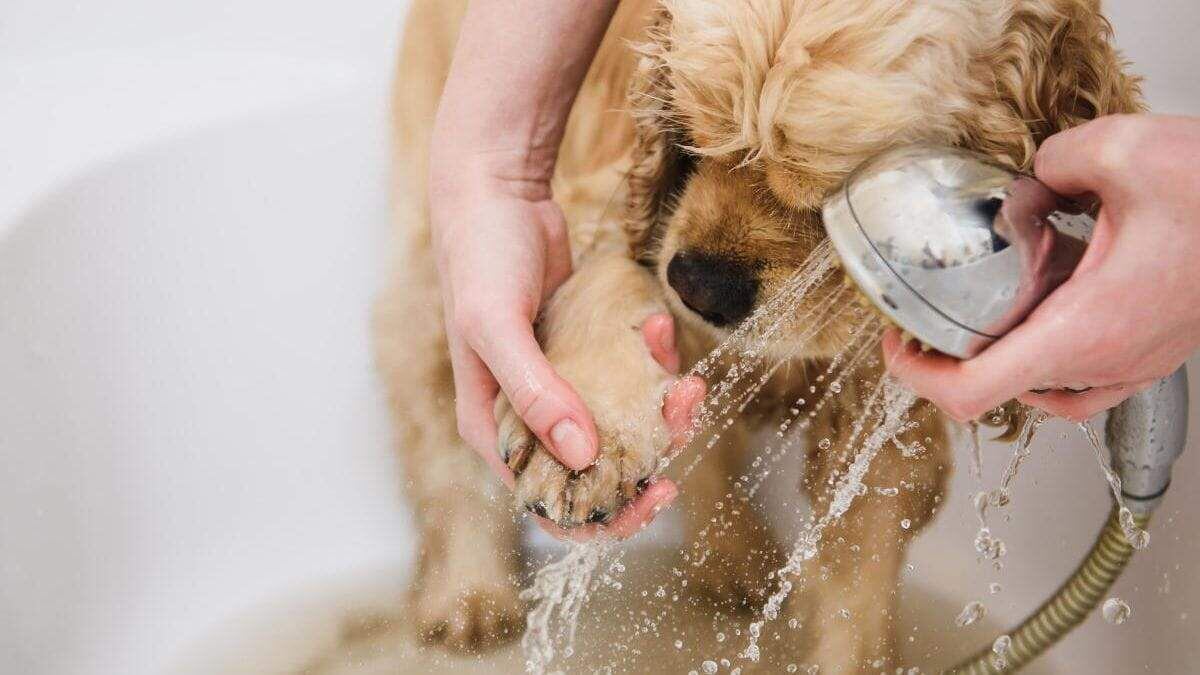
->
xmin=413 ymin=569 xmax=524 ymax=653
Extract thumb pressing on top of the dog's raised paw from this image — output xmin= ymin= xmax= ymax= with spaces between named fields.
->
xmin=473 ymin=315 xmax=598 ymax=471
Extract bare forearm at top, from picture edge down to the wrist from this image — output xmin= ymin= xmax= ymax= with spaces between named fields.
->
xmin=432 ymin=0 xmax=617 ymax=192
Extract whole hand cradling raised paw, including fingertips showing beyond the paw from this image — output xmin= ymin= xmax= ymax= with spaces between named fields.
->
xmin=432 ymin=172 xmax=704 ymax=540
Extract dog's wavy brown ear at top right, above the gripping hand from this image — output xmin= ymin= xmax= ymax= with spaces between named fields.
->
xmin=971 ymin=0 xmax=1144 ymax=171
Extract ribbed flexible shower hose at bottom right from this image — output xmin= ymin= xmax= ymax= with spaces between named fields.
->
xmin=947 ymin=508 xmax=1150 ymax=675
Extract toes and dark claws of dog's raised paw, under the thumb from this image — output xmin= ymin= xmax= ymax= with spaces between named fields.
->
xmin=496 ymin=395 xmax=666 ymax=528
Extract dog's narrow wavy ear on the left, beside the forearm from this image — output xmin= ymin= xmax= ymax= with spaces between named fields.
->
xmin=624 ymin=6 xmax=695 ymax=263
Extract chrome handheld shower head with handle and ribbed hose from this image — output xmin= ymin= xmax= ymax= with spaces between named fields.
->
xmin=824 ymin=145 xmax=1188 ymax=673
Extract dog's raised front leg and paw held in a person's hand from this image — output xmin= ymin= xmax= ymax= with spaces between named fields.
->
xmin=497 ymin=252 xmax=672 ymax=527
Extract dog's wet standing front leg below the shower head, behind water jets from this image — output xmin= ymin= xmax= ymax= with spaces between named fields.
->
xmin=791 ymin=374 xmax=950 ymax=673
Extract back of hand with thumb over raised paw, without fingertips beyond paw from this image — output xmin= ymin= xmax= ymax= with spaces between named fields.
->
xmin=430 ymin=170 xmax=598 ymax=485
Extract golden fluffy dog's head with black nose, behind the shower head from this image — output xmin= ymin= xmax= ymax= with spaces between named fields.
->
xmin=625 ymin=0 xmax=1139 ymax=356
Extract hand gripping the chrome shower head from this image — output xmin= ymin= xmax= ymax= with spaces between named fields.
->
xmin=883 ymin=115 xmax=1200 ymax=420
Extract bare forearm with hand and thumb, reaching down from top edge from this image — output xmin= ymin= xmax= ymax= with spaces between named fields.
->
xmin=428 ymin=0 xmax=617 ymax=478
